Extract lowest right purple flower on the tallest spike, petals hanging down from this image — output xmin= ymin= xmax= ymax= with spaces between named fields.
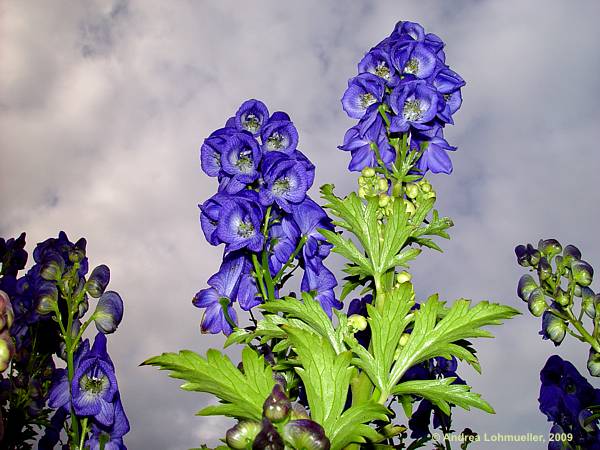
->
xmin=410 ymin=125 xmax=456 ymax=174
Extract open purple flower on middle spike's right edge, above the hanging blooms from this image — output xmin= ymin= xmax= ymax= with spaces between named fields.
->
xmin=259 ymin=152 xmax=308 ymax=212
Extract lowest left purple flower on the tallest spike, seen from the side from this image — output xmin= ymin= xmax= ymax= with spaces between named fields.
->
xmin=338 ymin=105 xmax=396 ymax=172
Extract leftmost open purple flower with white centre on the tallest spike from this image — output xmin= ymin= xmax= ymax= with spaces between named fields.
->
xmin=342 ymin=73 xmax=385 ymax=119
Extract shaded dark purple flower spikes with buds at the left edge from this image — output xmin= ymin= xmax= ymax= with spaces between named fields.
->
xmin=0 ymin=231 xmax=129 ymax=449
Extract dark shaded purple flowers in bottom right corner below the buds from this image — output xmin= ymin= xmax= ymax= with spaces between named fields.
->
xmin=539 ymin=355 xmax=600 ymax=450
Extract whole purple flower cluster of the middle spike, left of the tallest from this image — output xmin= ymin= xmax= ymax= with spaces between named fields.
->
xmin=193 ymin=100 xmax=340 ymax=334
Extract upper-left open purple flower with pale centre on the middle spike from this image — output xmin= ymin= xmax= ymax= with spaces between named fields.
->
xmin=219 ymin=132 xmax=261 ymax=194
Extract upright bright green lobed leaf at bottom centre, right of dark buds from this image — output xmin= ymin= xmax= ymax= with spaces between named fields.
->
xmin=284 ymin=326 xmax=388 ymax=450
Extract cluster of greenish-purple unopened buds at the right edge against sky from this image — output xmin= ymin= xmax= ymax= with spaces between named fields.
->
xmin=515 ymin=239 xmax=600 ymax=376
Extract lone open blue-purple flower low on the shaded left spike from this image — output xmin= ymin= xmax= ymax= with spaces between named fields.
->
xmin=71 ymin=333 xmax=118 ymax=426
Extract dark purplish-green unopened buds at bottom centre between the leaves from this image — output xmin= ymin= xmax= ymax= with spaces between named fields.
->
xmin=225 ymin=383 xmax=331 ymax=450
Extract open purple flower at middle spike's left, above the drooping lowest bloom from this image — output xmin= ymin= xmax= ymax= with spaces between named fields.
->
xmin=216 ymin=196 xmax=264 ymax=252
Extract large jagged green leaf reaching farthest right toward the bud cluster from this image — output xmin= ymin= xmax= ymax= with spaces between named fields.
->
xmin=385 ymin=295 xmax=520 ymax=392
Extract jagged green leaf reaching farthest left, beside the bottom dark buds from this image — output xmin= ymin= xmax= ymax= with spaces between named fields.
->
xmin=142 ymin=347 xmax=275 ymax=421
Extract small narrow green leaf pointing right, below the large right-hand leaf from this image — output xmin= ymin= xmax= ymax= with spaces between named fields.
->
xmin=392 ymin=377 xmax=494 ymax=416
